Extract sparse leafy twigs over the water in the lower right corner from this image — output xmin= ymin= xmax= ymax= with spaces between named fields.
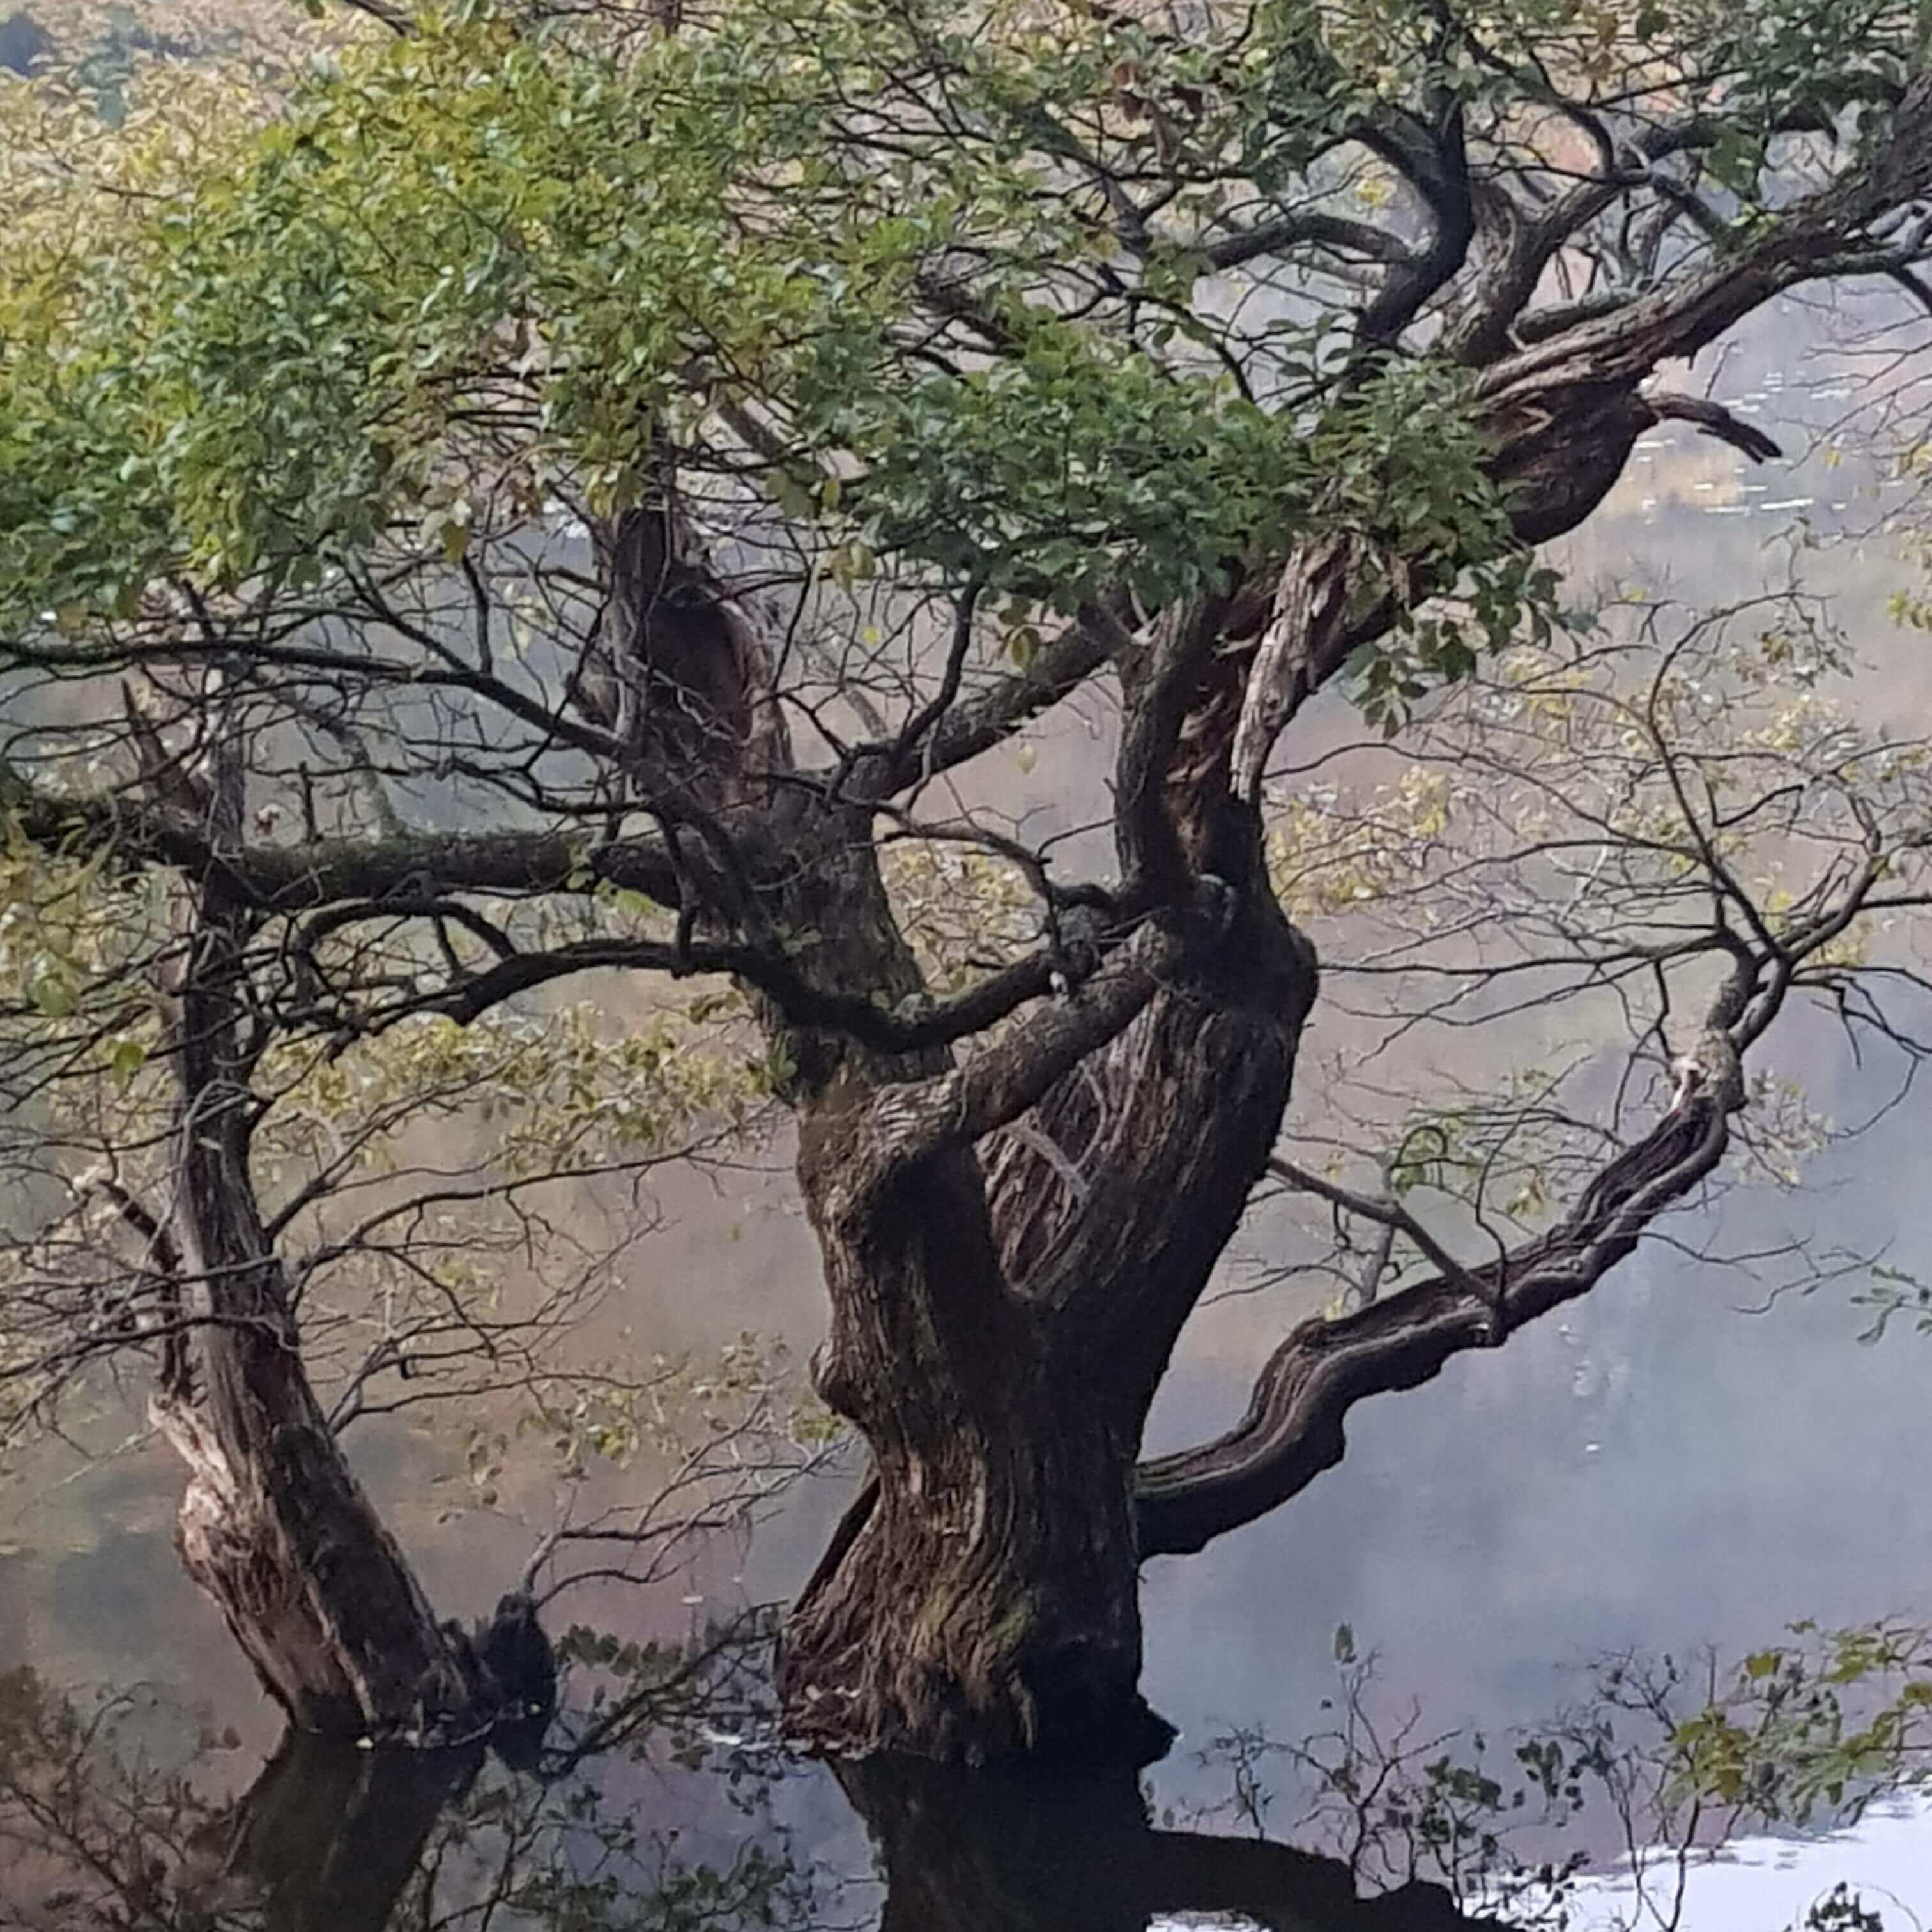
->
xmin=1202 ymin=1623 xmax=1932 ymax=1932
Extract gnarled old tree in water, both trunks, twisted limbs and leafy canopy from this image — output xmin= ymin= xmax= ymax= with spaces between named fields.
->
xmin=0 ymin=0 xmax=1932 ymax=1756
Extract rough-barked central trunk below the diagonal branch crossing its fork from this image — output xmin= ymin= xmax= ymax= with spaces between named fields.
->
xmin=786 ymin=942 xmax=1306 ymax=1756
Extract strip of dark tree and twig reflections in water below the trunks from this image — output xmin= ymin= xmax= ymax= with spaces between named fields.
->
xmin=0 ymin=1617 xmax=1932 ymax=1932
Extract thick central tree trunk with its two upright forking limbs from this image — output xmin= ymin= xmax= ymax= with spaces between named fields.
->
xmin=560 ymin=502 xmax=1314 ymax=1762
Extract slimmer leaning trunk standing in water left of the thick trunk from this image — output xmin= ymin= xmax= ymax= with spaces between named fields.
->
xmin=151 ymin=794 xmax=547 ymax=1743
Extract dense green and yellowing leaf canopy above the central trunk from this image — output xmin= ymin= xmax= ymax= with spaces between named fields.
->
xmin=0 ymin=0 xmax=1538 ymax=630
